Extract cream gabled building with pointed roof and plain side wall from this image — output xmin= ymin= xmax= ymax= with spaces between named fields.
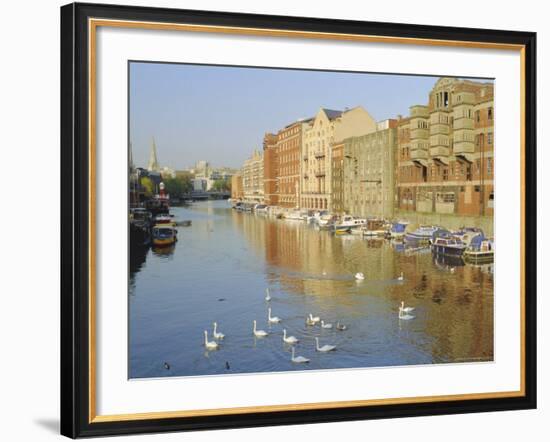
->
xmin=300 ymin=106 xmax=376 ymax=210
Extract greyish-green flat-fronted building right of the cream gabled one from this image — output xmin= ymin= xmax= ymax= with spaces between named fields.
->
xmin=340 ymin=120 xmax=397 ymax=218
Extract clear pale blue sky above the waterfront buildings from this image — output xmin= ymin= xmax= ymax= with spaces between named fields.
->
xmin=129 ymin=62 xmax=496 ymax=170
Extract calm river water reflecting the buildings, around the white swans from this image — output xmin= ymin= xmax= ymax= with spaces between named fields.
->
xmin=129 ymin=201 xmax=493 ymax=378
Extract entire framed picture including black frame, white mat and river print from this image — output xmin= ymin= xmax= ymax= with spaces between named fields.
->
xmin=61 ymin=0 xmax=536 ymax=438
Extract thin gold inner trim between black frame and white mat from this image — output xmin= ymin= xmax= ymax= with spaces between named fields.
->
xmin=88 ymin=18 xmax=526 ymax=423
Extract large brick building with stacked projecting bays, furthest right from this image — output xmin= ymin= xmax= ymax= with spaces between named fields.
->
xmin=396 ymin=78 xmax=494 ymax=234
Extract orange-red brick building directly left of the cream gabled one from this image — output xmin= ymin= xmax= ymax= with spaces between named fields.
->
xmin=277 ymin=120 xmax=311 ymax=208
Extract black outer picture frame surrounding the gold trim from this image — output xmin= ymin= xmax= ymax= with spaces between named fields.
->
xmin=61 ymin=3 xmax=537 ymax=438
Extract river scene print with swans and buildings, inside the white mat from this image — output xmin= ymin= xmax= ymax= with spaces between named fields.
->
xmin=128 ymin=61 xmax=495 ymax=379
